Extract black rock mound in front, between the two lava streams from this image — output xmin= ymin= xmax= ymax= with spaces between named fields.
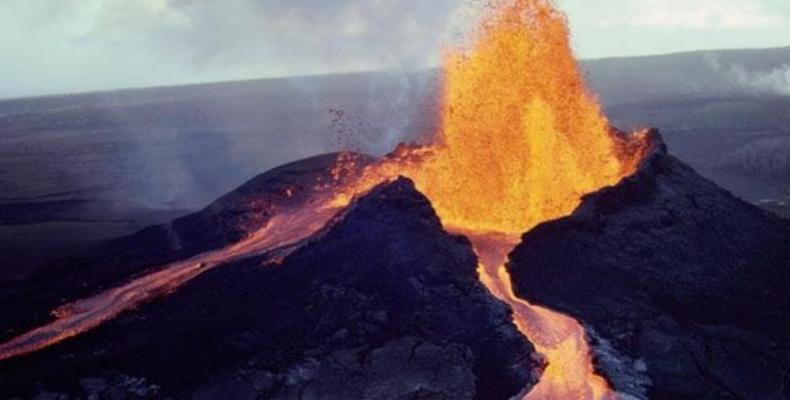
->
xmin=0 ymin=179 xmax=540 ymax=399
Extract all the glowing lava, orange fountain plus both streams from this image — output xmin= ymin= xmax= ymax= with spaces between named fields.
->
xmin=0 ymin=0 xmax=648 ymax=399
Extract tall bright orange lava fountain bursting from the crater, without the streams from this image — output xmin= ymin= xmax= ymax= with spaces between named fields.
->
xmin=339 ymin=0 xmax=643 ymax=234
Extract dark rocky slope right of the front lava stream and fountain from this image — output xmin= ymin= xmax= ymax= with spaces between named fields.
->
xmin=508 ymin=134 xmax=790 ymax=400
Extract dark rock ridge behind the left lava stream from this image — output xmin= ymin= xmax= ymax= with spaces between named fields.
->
xmin=0 ymin=153 xmax=373 ymax=340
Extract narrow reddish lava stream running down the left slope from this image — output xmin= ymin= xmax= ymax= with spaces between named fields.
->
xmin=0 ymin=196 xmax=340 ymax=361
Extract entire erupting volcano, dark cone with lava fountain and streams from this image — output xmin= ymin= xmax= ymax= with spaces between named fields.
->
xmin=0 ymin=0 xmax=790 ymax=400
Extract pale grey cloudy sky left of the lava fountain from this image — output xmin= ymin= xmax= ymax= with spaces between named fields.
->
xmin=0 ymin=0 xmax=484 ymax=97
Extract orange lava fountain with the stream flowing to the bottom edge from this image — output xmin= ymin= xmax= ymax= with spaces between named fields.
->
xmin=420 ymin=0 xmax=644 ymax=400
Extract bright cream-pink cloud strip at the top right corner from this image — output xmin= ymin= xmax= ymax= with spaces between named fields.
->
xmin=602 ymin=0 xmax=789 ymax=30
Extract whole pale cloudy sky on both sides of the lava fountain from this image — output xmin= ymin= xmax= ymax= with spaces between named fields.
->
xmin=0 ymin=0 xmax=790 ymax=98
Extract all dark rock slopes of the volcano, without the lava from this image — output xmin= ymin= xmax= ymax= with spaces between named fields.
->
xmin=0 ymin=131 xmax=790 ymax=399
